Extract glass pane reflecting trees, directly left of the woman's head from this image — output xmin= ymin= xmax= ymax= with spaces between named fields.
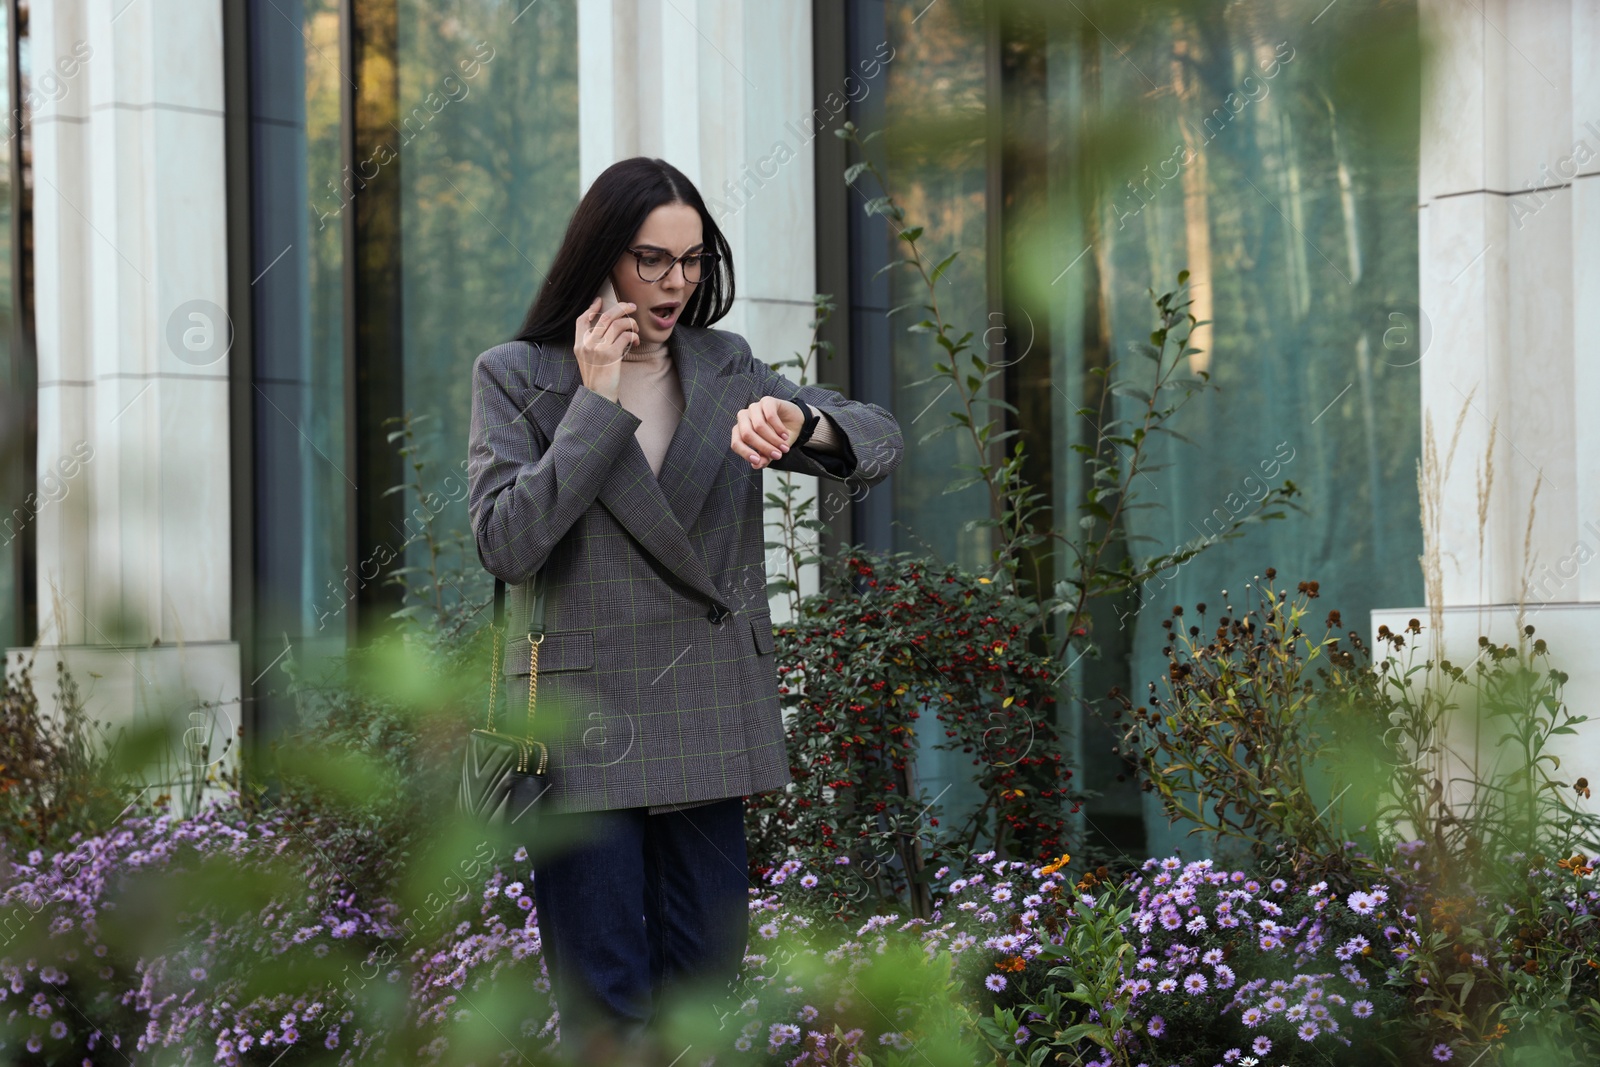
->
xmin=395 ymin=0 xmax=581 ymax=617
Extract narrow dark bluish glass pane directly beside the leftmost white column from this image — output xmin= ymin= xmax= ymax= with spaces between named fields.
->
xmin=250 ymin=0 xmax=355 ymax=685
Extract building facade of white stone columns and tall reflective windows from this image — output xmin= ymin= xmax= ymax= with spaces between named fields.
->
xmin=0 ymin=0 xmax=1600 ymax=848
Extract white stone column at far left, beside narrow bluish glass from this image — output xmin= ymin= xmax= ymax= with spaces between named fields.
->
xmin=8 ymin=0 xmax=238 ymax=793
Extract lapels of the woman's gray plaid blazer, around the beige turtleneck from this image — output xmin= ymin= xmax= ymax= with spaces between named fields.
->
xmin=528 ymin=337 xmax=733 ymax=614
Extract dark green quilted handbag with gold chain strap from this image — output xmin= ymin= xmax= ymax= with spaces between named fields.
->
xmin=458 ymin=573 xmax=550 ymax=829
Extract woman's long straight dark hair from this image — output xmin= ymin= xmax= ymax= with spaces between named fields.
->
xmin=515 ymin=155 xmax=733 ymax=344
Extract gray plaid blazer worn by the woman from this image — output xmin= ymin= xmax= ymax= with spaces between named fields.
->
xmin=467 ymin=325 xmax=902 ymax=811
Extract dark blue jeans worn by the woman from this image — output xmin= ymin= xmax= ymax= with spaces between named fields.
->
xmin=533 ymin=797 xmax=750 ymax=1054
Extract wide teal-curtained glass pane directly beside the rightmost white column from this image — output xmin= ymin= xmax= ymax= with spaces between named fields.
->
xmin=1051 ymin=0 xmax=1422 ymax=854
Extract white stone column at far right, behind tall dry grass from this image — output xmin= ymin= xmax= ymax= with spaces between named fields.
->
xmin=1373 ymin=0 xmax=1600 ymax=758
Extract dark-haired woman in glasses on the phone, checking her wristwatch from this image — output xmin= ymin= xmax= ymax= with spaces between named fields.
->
xmin=469 ymin=157 xmax=902 ymax=1056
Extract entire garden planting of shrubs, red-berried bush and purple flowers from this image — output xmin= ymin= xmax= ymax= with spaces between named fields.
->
xmin=0 ymin=543 xmax=1600 ymax=1067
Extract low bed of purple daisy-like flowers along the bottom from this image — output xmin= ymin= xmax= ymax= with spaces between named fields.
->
xmin=0 ymin=796 xmax=1600 ymax=1067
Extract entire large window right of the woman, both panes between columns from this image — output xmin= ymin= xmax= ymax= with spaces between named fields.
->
xmin=853 ymin=0 xmax=1422 ymax=853
